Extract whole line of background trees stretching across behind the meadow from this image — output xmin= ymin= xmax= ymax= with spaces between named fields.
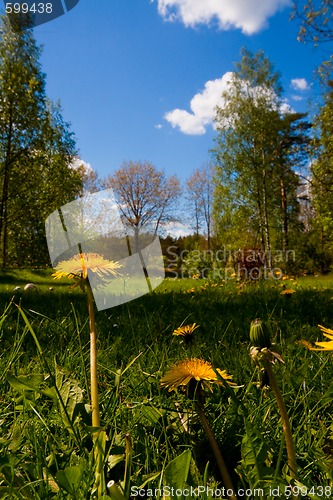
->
xmin=0 ymin=2 xmax=333 ymax=272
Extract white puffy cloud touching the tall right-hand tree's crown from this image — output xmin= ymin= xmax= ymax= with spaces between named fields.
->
xmin=164 ymin=72 xmax=232 ymax=135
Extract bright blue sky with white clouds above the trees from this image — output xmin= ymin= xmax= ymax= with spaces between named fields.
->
xmin=29 ymin=0 xmax=327 ymax=184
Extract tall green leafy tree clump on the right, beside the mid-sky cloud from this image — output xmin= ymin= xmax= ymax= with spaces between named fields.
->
xmin=213 ymin=49 xmax=309 ymax=267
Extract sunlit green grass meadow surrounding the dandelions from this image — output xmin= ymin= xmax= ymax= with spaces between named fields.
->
xmin=0 ymin=270 xmax=333 ymax=500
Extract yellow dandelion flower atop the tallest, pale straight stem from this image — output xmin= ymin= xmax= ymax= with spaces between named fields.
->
xmin=52 ymin=253 xmax=121 ymax=279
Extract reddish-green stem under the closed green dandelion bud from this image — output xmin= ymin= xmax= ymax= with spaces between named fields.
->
xmin=264 ymin=359 xmax=297 ymax=482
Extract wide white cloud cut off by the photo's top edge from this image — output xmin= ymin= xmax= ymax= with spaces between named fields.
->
xmin=158 ymin=0 xmax=292 ymax=35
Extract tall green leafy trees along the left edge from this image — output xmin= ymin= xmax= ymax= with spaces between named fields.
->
xmin=0 ymin=16 xmax=82 ymax=268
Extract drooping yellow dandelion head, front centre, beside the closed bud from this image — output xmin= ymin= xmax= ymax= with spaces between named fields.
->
xmin=160 ymin=358 xmax=235 ymax=392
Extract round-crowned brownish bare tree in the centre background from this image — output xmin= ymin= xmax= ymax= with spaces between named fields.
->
xmin=104 ymin=161 xmax=181 ymax=238
